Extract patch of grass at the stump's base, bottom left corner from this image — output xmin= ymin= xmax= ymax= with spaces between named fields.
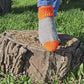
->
xmin=0 ymin=72 xmax=32 ymax=84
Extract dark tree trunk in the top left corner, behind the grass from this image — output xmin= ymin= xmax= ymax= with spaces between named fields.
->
xmin=0 ymin=0 xmax=11 ymax=13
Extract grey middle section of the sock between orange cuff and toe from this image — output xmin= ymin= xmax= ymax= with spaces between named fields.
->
xmin=39 ymin=17 xmax=59 ymax=45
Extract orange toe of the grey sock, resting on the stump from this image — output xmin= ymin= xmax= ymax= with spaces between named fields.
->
xmin=43 ymin=40 xmax=60 ymax=51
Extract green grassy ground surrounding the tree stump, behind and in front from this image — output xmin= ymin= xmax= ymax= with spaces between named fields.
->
xmin=0 ymin=0 xmax=84 ymax=84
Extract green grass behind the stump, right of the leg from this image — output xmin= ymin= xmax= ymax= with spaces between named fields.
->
xmin=55 ymin=0 xmax=84 ymax=42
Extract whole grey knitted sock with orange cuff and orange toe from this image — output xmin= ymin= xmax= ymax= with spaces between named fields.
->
xmin=38 ymin=6 xmax=60 ymax=51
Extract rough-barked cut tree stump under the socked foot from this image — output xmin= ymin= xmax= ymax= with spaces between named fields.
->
xmin=0 ymin=30 xmax=84 ymax=82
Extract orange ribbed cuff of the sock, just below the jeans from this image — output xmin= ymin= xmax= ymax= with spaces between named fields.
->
xmin=38 ymin=6 xmax=54 ymax=20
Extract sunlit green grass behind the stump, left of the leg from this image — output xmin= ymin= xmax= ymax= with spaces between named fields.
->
xmin=0 ymin=0 xmax=38 ymax=33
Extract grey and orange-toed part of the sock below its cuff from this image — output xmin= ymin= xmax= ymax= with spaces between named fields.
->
xmin=39 ymin=17 xmax=59 ymax=51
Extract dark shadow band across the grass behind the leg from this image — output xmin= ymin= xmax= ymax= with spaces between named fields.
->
xmin=11 ymin=0 xmax=84 ymax=14
